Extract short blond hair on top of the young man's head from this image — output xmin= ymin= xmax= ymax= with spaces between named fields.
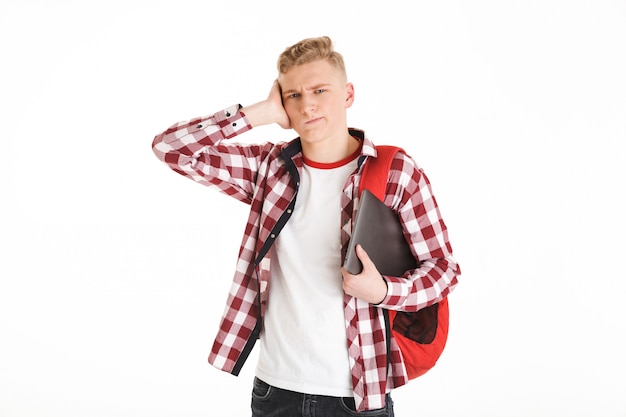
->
xmin=278 ymin=36 xmax=347 ymax=78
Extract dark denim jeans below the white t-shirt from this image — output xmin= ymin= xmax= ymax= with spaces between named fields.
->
xmin=252 ymin=378 xmax=394 ymax=417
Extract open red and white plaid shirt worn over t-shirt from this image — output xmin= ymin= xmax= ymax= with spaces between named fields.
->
xmin=152 ymin=105 xmax=460 ymax=411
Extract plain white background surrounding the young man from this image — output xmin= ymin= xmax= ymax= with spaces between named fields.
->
xmin=0 ymin=0 xmax=626 ymax=417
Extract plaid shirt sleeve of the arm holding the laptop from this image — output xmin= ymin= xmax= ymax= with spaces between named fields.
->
xmin=379 ymin=152 xmax=461 ymax=311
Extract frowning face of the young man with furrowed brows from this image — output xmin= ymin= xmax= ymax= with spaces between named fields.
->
xmin=278 ymin=60 xmax=354 ymax=143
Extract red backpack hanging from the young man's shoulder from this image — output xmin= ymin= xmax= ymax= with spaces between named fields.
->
xmin=359 ymin=146 xmax=449 ymax=379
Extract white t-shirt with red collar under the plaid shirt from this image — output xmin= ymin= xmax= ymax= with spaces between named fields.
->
xmin=256 ymin=155 xmax=357 ymax=397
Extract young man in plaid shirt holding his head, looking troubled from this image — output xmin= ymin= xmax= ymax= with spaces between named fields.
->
xmin=152 ymin=37 xmax=460 ymax=417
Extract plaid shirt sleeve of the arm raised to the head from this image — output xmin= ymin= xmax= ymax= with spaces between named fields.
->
xmin=152 ymin=105 xmax=273 ymax=204
